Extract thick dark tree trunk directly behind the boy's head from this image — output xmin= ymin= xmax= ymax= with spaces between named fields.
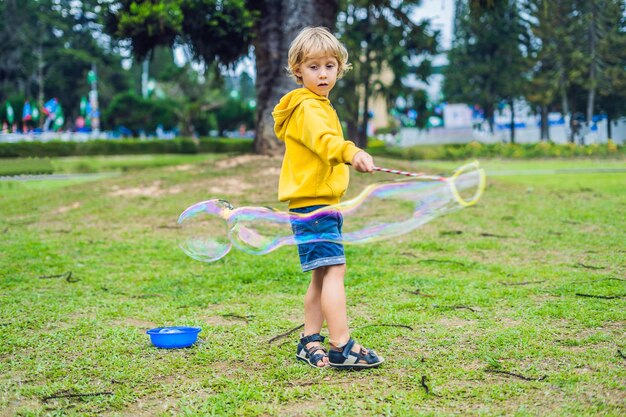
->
xmin=254 ymin=0 xmax=339 ymax=155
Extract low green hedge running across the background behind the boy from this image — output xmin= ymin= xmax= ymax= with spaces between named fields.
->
xmin=0 ymin=138 xmax=626 ymax=176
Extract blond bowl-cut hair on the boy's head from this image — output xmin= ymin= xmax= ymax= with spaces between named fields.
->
xmin=286 ymin=26 xmax=352 ymax=84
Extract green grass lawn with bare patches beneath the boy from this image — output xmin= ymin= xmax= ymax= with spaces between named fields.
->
xmin=0 ymin=155 xmax=626 ymax=416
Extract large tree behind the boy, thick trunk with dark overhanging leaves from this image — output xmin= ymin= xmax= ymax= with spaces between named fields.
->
xmin=106 ymin=0 xmax=338 ymax=154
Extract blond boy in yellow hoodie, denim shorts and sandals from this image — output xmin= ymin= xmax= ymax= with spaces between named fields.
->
xmin=272 ymin=27 xmax=383 ymax=368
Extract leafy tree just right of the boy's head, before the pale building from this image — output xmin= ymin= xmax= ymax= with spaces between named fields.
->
xmin=336 ymin=0 xmax=437 ymax=147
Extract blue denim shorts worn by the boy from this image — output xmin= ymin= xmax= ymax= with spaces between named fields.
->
xmin=291 ymin=206 xmax=346 ymax=272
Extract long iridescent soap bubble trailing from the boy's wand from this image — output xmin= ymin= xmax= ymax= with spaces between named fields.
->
xmin=178 ymin=164 xmax=484 ymax=262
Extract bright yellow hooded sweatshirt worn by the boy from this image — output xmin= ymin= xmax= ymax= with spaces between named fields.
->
xmin=272 ymin=88 xmax=360 ymax=209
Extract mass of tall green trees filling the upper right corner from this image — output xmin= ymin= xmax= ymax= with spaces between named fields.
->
xmin=444 ymin=0 xmax=626 ymax=140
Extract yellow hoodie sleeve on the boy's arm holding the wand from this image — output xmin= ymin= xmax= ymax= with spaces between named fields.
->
xmin=300 ymin=100 xmax=361 ymax=165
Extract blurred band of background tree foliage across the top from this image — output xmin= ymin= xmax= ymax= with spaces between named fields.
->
xmin=0 ymin=0 xmax=626 ymax=146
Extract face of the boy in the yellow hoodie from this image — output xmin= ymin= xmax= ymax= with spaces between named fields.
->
xmin=295 ymin=54 xmax=339 ymax=98
